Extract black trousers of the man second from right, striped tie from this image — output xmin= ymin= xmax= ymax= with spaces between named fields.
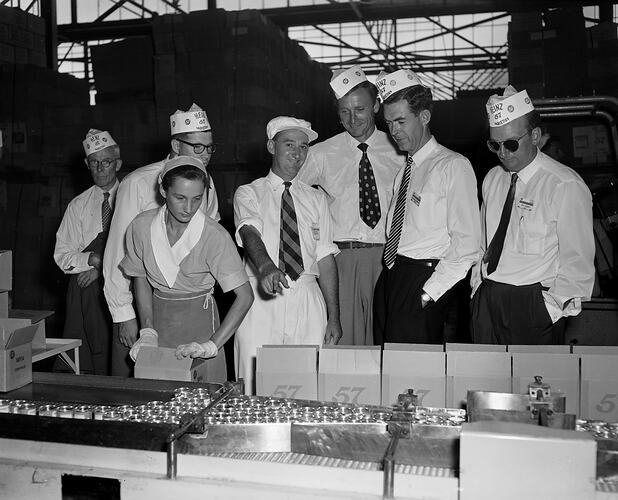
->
xmin=373 ymin=255 xmax=452 ymax=345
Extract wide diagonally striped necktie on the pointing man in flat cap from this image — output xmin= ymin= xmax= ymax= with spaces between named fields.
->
xmin=279 ymin=182 xmax=304 ymax=281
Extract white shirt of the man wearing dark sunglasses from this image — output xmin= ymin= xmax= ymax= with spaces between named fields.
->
xmin=471 ymin=151 xmax=595 ymax=322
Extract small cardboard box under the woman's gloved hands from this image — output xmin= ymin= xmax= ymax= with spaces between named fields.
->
xmin=134 ymin=346 xmax=209 ymax=382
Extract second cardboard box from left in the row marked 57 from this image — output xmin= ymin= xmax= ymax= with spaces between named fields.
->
xmin=318 ymin=346 xmax=381 ymax=405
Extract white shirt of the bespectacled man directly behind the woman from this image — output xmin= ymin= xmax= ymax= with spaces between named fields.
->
xmin=103 ymin=156 xmax=219 ymax=323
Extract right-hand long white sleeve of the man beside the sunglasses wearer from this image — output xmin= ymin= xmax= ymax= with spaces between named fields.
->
xmin=423 ymin=160 xmax=481 ymax=300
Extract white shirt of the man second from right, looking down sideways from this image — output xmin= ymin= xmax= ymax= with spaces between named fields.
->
xmin=388 ymin=137 xmax=481 ymax=300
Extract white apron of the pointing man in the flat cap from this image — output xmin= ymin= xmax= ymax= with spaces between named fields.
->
xmin=234 ymin=274 xmax=327 ymax=395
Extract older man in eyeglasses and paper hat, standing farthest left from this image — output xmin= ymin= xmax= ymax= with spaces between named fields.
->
xmin=54 ymin=129 xmax=122 ymax=375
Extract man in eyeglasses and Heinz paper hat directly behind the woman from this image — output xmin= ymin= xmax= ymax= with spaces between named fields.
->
xmin=103 ymin=104 xmax=219 ymax=377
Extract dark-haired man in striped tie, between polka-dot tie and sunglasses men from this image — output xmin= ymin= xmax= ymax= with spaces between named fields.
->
xmin=374 ymin=70 xmax=481 ymax=344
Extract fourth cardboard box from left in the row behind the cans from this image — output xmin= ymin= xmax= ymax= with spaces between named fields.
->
xmin=446 ymin=344 xmax=512 ymax=408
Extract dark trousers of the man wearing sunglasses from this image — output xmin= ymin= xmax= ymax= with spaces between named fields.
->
xmin=471 ymin=280 xmax=566 ymax=345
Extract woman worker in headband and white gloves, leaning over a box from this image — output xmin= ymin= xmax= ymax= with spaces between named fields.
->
xmin=120 ymin=156 xmax=253 ymax=382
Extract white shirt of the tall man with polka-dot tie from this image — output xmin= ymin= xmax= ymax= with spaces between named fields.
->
xmin=297 ymin=129 xmax=406 ymax=243
